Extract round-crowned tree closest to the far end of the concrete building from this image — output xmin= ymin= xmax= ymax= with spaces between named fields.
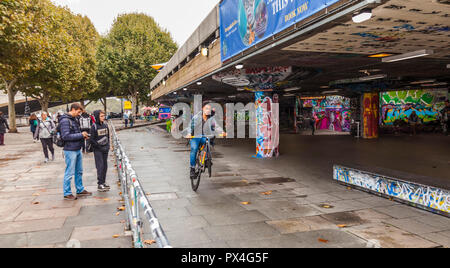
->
xmin=97 ymin=13 xmax=177 ymax=114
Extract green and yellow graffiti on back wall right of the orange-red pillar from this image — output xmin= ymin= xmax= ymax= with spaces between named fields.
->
xmin=380 ymin=90 xmax=449 ymax=126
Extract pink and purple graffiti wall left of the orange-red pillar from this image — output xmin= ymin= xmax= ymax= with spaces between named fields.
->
xmin=301 ymin=96 xmax=352 ymax=132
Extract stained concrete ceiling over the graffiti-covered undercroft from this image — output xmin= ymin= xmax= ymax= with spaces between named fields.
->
xmin=160 ymin=0 xmax=450 ymax=101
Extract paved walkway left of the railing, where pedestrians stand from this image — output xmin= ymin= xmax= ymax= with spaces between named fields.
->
xmin=0 ymin=128 xmax=132 ymax=248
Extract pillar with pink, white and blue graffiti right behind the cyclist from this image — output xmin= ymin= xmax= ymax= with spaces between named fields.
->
xmin=254 ymin=91 xmax=280 ymax=158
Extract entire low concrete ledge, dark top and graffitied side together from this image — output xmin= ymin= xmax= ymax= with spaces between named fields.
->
xmin=333 ymin=165 xmax=450 ymax=217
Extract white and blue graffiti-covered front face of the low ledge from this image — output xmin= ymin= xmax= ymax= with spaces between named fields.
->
xmin=334 ymin=165 xmax=450 ymax=217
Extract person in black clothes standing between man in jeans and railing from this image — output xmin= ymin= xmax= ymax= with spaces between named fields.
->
xmin=89 ymin=111 xmax=110 ymax=192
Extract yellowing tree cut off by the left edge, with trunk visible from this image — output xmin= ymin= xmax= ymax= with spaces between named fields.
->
xmin=0 ymin=0 xmax=51 ymax=132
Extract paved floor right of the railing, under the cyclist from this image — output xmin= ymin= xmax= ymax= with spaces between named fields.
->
xmin=118 ymin=126 xmax=450 ymax=248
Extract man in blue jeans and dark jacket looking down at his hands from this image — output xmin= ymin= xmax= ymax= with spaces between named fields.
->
xmin=59 ymin=103 xmax=92 ymax=201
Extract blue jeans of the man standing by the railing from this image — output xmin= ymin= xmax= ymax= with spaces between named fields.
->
xmin=63 ymin=150 xmax=84 ymax=196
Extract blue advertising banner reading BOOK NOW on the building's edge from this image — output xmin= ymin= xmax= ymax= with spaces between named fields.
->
xmin=220 ymin=0 xmax=339 ymax=61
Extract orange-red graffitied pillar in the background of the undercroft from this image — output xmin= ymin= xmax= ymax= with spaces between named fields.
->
xmin=361 ymin=93 xmax=380 ymax=139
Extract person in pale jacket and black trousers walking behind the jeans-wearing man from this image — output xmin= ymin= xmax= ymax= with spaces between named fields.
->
xmin=34 ymin=112 xmax=56 ymax=163
